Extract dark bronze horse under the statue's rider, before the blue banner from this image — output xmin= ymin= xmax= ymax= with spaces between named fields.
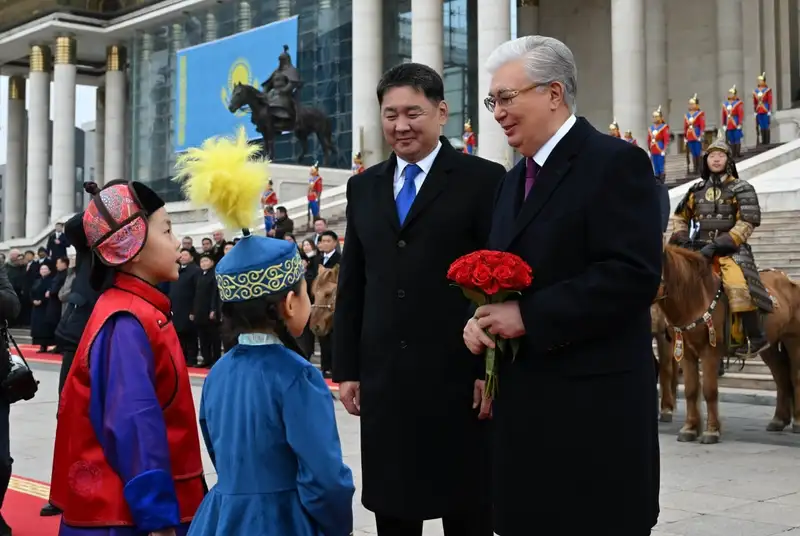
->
xmin=228 ymin=82 xmax=337 ymax=165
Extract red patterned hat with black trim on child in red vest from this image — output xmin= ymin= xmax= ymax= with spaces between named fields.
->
xmin=83 ymin=180 xmax=164 ymax=282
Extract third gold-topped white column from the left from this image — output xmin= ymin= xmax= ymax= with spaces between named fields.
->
xmin=50 ymin=35 xmax=78 ymax=222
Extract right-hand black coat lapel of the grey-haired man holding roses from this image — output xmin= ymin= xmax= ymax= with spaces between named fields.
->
xmin=505 ymin=117 xmax=593 ymax=247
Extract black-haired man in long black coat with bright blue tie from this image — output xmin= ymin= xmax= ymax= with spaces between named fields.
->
xmin=333 ymin=63 xmax=505 ymax=536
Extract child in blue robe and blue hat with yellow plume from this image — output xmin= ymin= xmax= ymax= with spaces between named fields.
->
xmin=178 ymin=127 xmax=355 ymax=536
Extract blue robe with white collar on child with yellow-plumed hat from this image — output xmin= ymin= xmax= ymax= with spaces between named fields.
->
xmin=189 ymin=334 xmax=355 ymax=536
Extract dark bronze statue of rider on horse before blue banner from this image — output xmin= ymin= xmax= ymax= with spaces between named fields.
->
xmin=228 ymin=45 xmax=336 ymax=165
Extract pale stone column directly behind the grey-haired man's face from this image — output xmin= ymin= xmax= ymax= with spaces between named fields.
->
xmin=473 ymin=0 xmax=512 ymax=168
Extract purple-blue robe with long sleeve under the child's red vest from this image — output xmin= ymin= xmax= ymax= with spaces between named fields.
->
xmin=58 ymin=314 xmax=189 ymax=536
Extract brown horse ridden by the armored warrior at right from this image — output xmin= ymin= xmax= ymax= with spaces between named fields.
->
xmin=657 ymin=245 xmax=800 ymax=444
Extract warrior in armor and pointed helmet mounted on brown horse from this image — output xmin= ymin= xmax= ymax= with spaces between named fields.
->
xmin=656 ymin=132 xmax=800 ymax=444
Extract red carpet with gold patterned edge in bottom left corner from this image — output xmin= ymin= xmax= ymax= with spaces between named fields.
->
xmin=3 ymin=476 xmax=61 ymax=536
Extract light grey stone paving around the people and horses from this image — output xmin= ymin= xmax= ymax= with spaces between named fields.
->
xmin=11 ymin=364 xmax=800 ymax=536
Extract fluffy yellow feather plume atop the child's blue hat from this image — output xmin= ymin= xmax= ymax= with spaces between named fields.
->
xmin=174 ymin=127 xmax=270 ymax=229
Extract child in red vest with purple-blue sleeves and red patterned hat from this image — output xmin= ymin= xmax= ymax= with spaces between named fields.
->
xmin=50 ymin=181 xmax=205 ymax=536
